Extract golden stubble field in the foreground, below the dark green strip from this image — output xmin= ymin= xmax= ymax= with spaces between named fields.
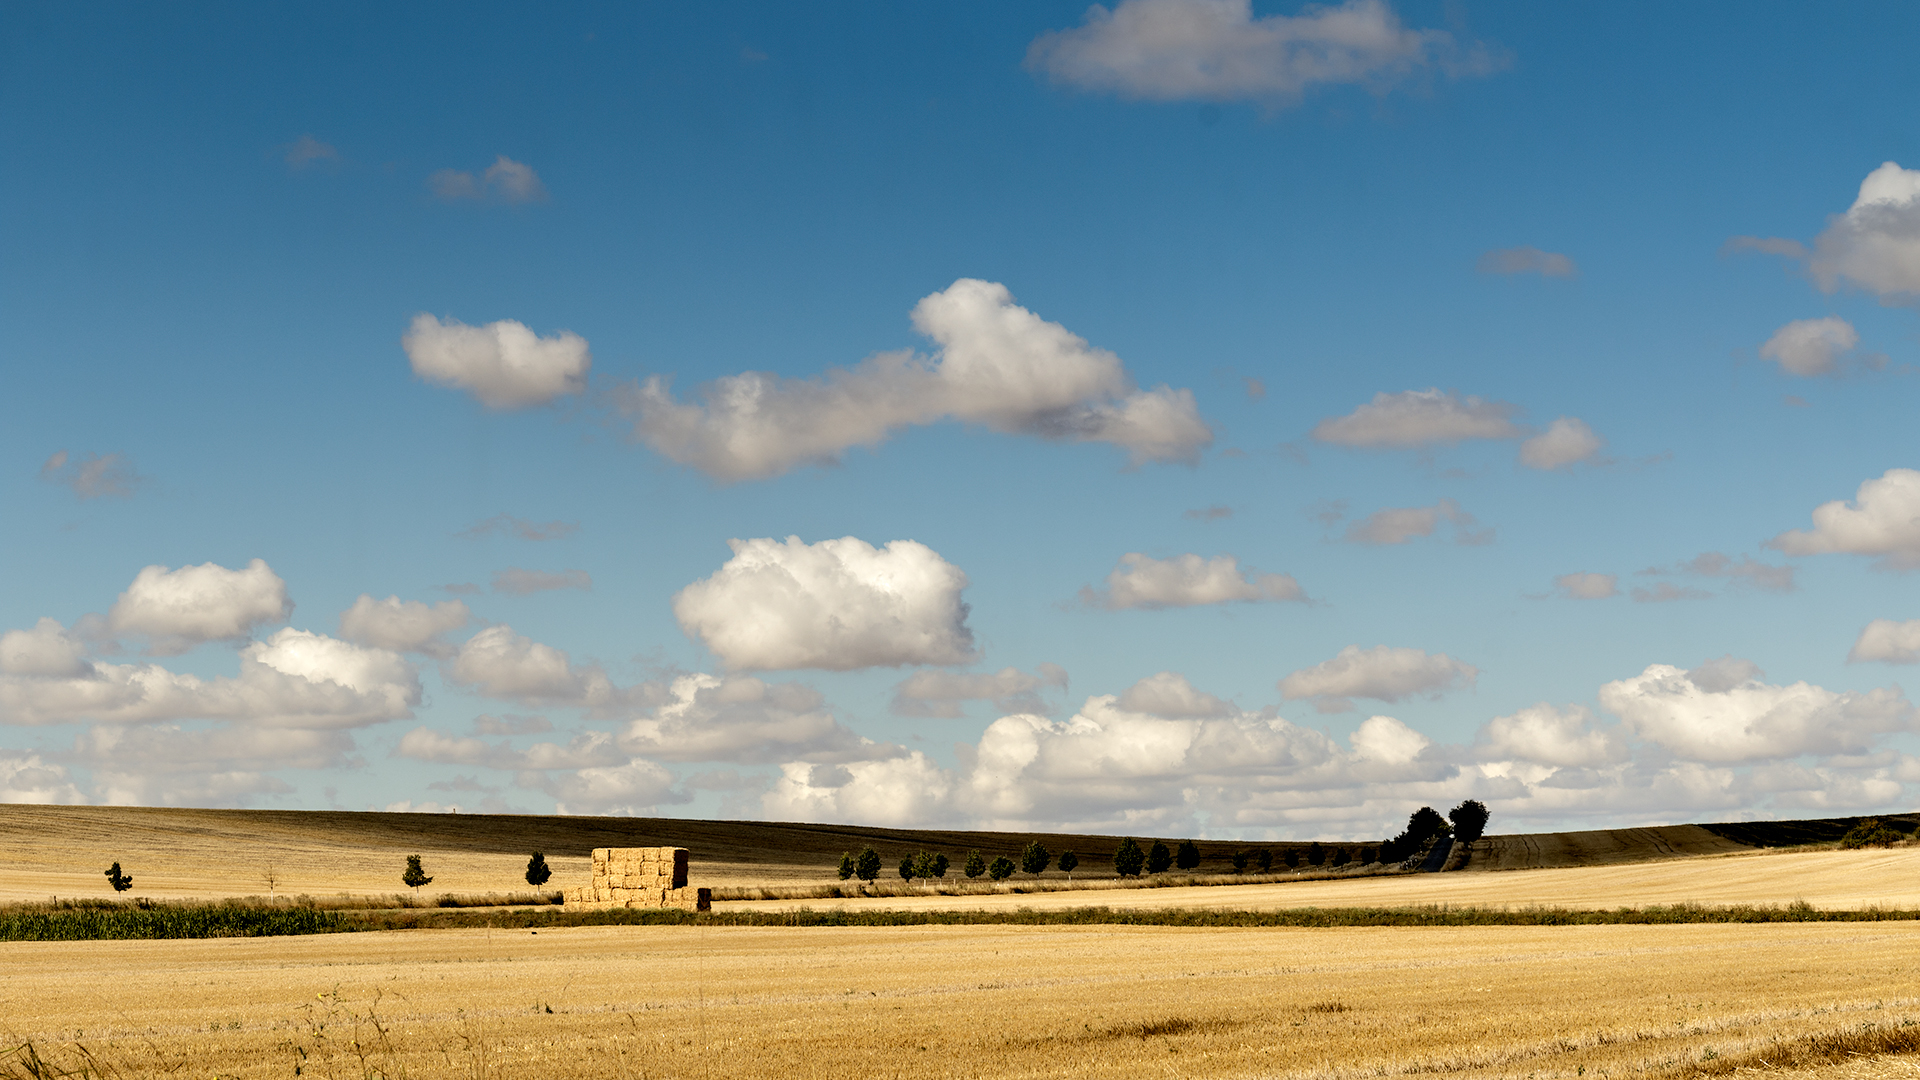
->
xmin=0 ymin=922 xmax=1920 ymax=1080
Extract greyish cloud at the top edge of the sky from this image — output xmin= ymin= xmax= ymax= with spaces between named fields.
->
xmin=1027 ymin=0 xmax=1496 ymax=104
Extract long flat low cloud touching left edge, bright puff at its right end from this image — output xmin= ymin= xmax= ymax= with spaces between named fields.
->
xmin=0 ymin=621 xmax=420 ymax=728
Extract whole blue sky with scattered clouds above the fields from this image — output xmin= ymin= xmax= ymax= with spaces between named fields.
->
xmin=0 ymin=0 xmax=1920 ymax=838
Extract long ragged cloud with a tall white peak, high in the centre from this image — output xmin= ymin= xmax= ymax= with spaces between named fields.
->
xmin=618 ymin=279 xmax=1213 ymax=480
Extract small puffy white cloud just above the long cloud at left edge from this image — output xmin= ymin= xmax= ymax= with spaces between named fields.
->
xmin=108 ymin=559 xmax=294 ymax=655
